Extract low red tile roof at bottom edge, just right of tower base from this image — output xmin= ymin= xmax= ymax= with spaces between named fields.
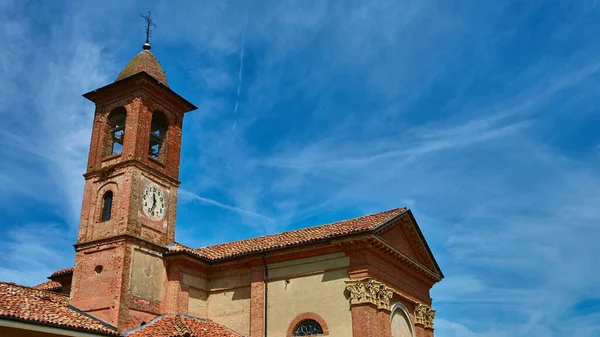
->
xmin=123 ymin=315 xmax=242 ymax=337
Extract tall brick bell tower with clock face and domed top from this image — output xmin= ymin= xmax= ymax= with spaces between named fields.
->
xmin=71 ymin=36 xmax=196 ymax=331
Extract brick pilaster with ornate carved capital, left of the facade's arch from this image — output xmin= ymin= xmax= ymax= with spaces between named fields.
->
xmin=346 ymin=277 xmax=393 ymax=337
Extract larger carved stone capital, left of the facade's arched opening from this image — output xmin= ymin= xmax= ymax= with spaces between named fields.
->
xmin=346 ymin=277 xmax=393 ymax=310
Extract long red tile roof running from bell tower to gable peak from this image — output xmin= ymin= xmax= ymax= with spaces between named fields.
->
xmin=169 ymin=207 xmax=406 ymax=261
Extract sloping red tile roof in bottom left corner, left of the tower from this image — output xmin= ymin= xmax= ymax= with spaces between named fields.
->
xmin=0 ymin=282 xmax=117 ymax=335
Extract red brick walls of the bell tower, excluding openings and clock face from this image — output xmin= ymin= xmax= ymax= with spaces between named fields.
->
xmin=71 ymin=77 xmax=189 ymax=331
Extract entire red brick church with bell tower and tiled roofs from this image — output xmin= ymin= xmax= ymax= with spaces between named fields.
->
xmin=0 ymin=33 xmax=443 ymax=337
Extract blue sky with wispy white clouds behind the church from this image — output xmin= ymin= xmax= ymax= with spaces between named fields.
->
xmin=0 ymin=0 xmax=600 ymax=337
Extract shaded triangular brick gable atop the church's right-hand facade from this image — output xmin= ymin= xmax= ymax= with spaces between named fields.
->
xmin=374 ymin=210 xmax=444 ymax=278
